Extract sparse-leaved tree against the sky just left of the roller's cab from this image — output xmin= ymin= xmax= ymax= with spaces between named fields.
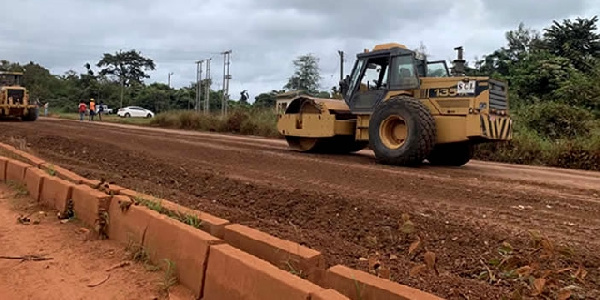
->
xmin=283 ymin=54 xmax=321 ymax=95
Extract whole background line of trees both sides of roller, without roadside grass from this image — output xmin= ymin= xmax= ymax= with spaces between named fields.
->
xmin=0 ymin=17 xmax=600 ymax=138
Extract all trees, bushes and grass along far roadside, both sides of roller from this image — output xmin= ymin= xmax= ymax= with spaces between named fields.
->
xmin=0 ymin=17 xmax=600 ymax=170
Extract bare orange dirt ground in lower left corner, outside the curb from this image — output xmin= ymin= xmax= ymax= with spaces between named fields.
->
xmin=0 ymin=184 xmax=182 ymax=300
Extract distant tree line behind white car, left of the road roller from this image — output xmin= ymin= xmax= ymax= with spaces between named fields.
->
xmin=0 ymin=49 xmax=330 ymax=112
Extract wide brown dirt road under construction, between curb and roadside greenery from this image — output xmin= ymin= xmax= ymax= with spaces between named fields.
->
xmin=0 ymin=120 xmax=600 ymax=299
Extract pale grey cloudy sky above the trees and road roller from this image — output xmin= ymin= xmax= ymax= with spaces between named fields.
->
xmin=0 ymin=0 xmax=600 ymax=100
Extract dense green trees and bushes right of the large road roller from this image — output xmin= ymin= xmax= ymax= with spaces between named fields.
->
xmin=470 ymin=17 xmax=600 ymax=170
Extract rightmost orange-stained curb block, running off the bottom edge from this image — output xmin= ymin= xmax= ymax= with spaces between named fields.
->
xmin=325 ymin=265 xmax=443 ymax=300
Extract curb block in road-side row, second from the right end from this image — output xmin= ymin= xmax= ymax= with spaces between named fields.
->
xmin=224 ymin=224 xmax=325 ymax=282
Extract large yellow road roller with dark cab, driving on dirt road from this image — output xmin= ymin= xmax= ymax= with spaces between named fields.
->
xmin=277 ymin=43 xmax=512 ymax=166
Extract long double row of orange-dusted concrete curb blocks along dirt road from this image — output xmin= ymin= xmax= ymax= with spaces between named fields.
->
xmin=0 ymin=143 xmax=442 ymax=300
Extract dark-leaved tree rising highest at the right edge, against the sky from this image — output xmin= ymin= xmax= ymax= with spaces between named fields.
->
xmin=544 ymin=16 xmax=600 ymax=71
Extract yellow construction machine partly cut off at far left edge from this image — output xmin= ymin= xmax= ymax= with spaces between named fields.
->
xmin=0 ymin=71 xmax=39 ymax=121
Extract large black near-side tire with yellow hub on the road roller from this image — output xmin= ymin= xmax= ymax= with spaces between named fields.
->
xmin=369 ymin=96 xmax=436 ymax=166
